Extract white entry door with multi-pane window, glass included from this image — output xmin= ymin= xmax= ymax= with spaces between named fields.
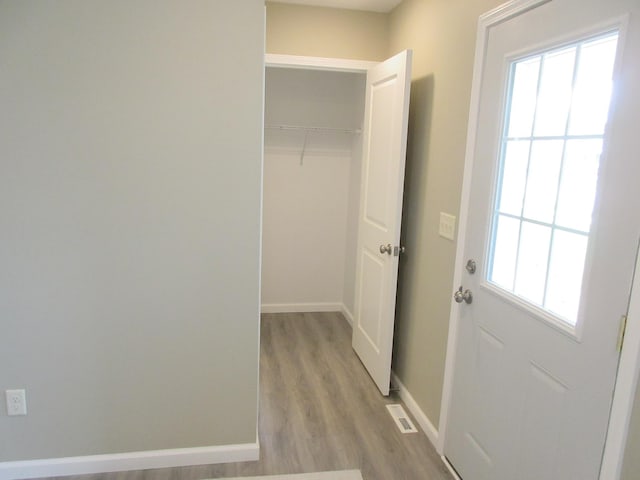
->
xmin=444 ymin=0 xmax=640 ymax=480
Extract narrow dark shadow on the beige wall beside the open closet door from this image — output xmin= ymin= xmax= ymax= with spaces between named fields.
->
xmin=392 ymin=75 xmax=435 ymax=372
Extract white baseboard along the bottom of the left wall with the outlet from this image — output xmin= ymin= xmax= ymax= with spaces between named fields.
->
xmin=0 ymin=442 xmax=260 ymax=480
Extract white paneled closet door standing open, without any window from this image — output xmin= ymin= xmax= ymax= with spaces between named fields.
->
xmin=352 ymin=51 xmax=411 ymax=395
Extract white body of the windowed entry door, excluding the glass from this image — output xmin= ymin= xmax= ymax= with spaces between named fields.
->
xmin=441 ymin=0 xmax=640 ymax=480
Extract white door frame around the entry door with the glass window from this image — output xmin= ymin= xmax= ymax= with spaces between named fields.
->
xmin=436 ymin=0 xmax=640 ymax=480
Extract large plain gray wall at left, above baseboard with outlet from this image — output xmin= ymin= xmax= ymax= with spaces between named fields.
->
xmin=0 ymin=0 xmax=264 ymax=461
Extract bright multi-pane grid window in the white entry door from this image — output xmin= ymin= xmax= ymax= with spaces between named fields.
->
xmin=487 ymin=32 xmax=618 ymax=326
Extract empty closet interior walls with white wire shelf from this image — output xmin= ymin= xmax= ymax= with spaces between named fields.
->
xmin=262 ymin=67 xmax=366 ymax=317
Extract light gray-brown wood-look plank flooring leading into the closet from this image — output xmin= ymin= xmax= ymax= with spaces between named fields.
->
xmin=47 ymin=313 xmax=452 ymax=480
